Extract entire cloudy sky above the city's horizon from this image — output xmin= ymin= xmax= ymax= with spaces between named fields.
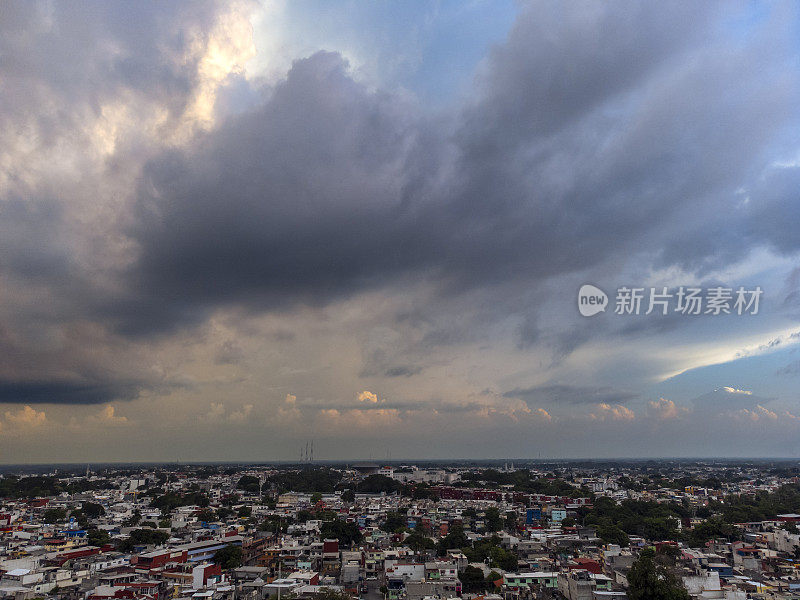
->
xmin=0 ymin=0 xmax=800 ymax=463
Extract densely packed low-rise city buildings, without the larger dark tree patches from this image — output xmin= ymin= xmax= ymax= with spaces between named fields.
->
xmin=0 ymin=465 xmax=800 ymax=600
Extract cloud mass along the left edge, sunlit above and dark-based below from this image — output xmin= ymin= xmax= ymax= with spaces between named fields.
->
xmin=0 ymin=1 xmax=234 ymax=404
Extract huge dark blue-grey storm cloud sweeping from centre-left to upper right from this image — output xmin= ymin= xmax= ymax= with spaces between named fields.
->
xmin=107 ymin=4 xmax=796 ymax=344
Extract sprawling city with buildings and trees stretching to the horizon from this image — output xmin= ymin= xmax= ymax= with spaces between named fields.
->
xmin=0 ymin=457 xmax=800 ymax=600
